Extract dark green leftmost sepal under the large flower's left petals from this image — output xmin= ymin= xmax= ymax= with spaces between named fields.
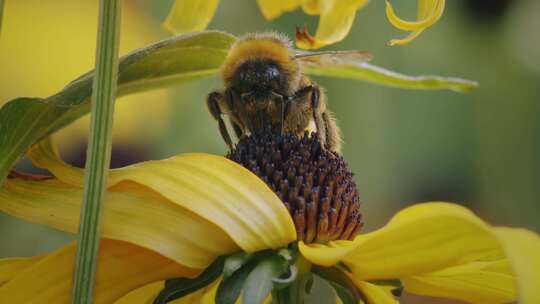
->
xmin=154 ymin=257 xmax=225 ymax=304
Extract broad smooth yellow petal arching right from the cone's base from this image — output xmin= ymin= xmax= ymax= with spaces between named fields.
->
xmin=300 ymin=203 xmax=501 ymax=280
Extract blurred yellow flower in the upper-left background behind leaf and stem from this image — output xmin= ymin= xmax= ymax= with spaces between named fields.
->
xmin=0 ymin=0 xmax=170 ymax=153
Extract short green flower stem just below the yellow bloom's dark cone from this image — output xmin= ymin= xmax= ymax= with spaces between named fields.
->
xmin=272 ymin=254 xmax=311 ymax=304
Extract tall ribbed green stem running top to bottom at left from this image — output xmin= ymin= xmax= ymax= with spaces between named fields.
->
xmin=72 ymin=0 xmax=120 ymax=304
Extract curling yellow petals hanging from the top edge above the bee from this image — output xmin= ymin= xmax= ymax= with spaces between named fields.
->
xmin=163 ymin=0 xmax=445 ymax=49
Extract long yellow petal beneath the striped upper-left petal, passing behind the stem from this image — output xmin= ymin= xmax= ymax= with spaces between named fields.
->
xmin=0 ymin=179 xmax=238 ymax=268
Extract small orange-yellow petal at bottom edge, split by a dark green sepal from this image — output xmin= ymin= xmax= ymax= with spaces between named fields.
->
xmin=114 ymin=281 xmax=204 ymax=304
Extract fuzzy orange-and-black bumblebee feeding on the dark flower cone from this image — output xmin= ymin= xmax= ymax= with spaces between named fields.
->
xmin=206 ymin=33 xmax=369 ymax=152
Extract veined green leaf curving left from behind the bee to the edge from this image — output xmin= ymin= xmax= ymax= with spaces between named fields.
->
xmin=0 ymin=31 xmax=236 ymax=183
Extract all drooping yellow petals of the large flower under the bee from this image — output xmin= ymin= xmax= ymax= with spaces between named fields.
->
xmin=0 ymin=135 xmax=540 ymax=304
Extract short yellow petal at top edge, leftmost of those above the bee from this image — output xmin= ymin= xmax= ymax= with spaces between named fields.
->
xmin=162 ymin=0 xmax=219 ymax=34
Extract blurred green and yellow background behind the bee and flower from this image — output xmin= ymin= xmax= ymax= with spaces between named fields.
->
xmin=0 ymin=0 xmax=540 ymax=290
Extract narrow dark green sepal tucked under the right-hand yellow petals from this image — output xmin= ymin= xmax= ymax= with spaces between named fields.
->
xmin=312 ymin=266 xmax=363 ymax=304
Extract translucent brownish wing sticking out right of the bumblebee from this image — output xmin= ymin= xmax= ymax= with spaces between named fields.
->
xmin=293 ymin=50 xmax=373 ymax=66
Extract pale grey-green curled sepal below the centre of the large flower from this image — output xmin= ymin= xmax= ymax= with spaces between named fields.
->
xmin=242 ymin=255 xmax=288 ymax=304
